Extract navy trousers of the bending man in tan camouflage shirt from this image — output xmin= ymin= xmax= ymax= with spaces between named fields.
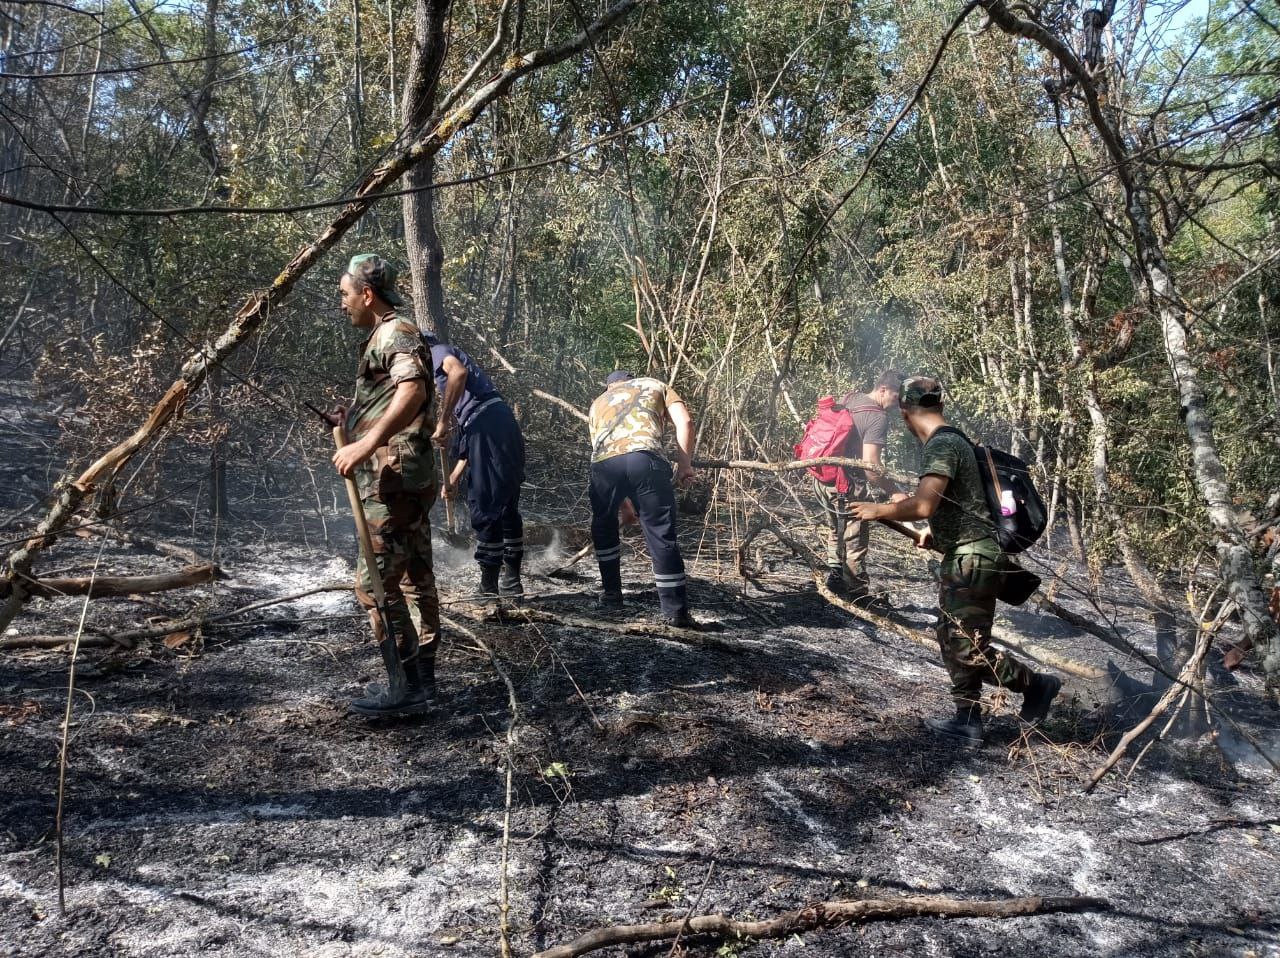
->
xmin=590 ymin=452 xmax=687 ymax=612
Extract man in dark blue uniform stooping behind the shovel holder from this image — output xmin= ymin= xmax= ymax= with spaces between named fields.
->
xmin=428 ymin=337 xmax=525 ymax=596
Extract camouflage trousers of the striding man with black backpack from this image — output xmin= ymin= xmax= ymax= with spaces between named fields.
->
xmin=937 ymin=539 xmax=1033 ymax=706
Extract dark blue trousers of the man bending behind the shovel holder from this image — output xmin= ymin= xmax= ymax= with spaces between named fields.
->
xmin=462 ymin=402 xmax=525 ymax=566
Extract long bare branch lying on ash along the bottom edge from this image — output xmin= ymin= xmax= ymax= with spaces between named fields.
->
xmin=534 ymin=895 xmax=1111 ymax=958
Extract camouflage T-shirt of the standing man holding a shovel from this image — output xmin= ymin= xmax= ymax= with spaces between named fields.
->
xmin=347 ymin=313 xmax=435 ymax=498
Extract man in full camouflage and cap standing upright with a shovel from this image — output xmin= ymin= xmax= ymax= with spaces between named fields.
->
xmin=333 ymin=254 xmax=440 ymax=716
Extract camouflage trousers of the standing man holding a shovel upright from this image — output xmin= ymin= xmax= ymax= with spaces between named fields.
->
xmin=356 ymin=487 xmax=440 ymax=662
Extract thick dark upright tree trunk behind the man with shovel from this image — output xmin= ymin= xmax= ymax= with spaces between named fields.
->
xmin=401 ymin=0 xmax=451 ymax=339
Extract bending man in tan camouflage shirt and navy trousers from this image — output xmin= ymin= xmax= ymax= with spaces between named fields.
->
xmin=589 ymin=370 xmax=696 ymax=629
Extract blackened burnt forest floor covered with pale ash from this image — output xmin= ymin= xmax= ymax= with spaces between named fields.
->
xmin=0 ymin=381 xmax=1280 ymax=958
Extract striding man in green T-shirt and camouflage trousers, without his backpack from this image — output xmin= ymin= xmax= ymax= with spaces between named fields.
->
xmin=852 ymin=377 xmax=1062 ymax=748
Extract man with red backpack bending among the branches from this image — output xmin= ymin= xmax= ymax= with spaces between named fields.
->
xmin=795 ymin=369 xmax=906 ymax=606
